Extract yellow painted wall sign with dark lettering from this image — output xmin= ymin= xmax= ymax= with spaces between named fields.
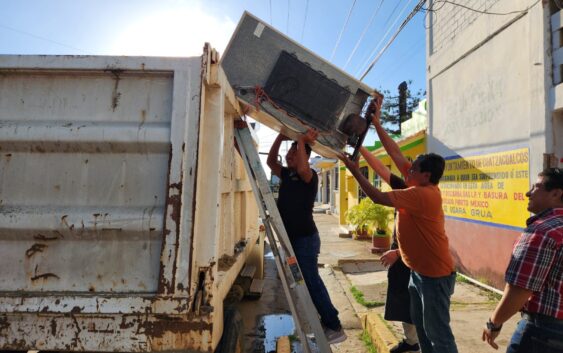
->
xmin=440 ymin=148 xmax=530 ymax=229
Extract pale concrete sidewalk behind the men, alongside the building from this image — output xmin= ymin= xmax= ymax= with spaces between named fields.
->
xmin=315 ymin=214 xmax=518 ymax=353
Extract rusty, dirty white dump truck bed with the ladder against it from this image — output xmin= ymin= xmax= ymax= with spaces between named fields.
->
xmin=0 ymin=46 xmax=263 ymax=352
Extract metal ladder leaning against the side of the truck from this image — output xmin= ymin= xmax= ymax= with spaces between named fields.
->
xmin=235 ymin=121 xmax=332 ymax=353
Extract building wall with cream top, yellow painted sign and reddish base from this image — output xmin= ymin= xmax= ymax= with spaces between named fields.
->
xmin=427 ymin=0 xmax=563 ymax=288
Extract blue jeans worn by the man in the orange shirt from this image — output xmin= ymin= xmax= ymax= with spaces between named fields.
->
xmin=409 ymin=271 xmax=457 ymax=353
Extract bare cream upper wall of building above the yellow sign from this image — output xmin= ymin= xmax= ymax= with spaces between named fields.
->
xmin=427 ymin=0 xmax=555 ymax=175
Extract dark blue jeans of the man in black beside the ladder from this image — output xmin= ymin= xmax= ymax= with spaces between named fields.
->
xmin=291 ymin=233 xmax=342 ymax=331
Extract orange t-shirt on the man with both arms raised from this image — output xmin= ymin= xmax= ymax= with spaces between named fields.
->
xmin=387 ymin=185 xmax=454 ymax=277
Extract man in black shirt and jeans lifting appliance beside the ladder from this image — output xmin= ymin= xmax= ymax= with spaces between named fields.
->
xmin=268 ymin=130 xmax=346 ymax=344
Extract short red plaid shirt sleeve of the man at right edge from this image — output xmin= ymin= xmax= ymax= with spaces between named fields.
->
xmin=505 ymin=227 xmax=557 ymax=292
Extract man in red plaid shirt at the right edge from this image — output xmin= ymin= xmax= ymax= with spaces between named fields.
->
xmin=483 ymin=168 xmax=563 ymax=353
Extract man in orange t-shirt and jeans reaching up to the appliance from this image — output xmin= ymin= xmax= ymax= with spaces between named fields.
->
xmin=340 ymin=98 xmax=458 ymax=353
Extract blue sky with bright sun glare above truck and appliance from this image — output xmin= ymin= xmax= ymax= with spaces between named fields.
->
xmin=0 ymin=0 xmax=426 ymax=160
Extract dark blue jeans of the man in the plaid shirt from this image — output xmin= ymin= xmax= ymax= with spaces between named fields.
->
xmin=506 ymin=316 xmax=563 ymax=353
